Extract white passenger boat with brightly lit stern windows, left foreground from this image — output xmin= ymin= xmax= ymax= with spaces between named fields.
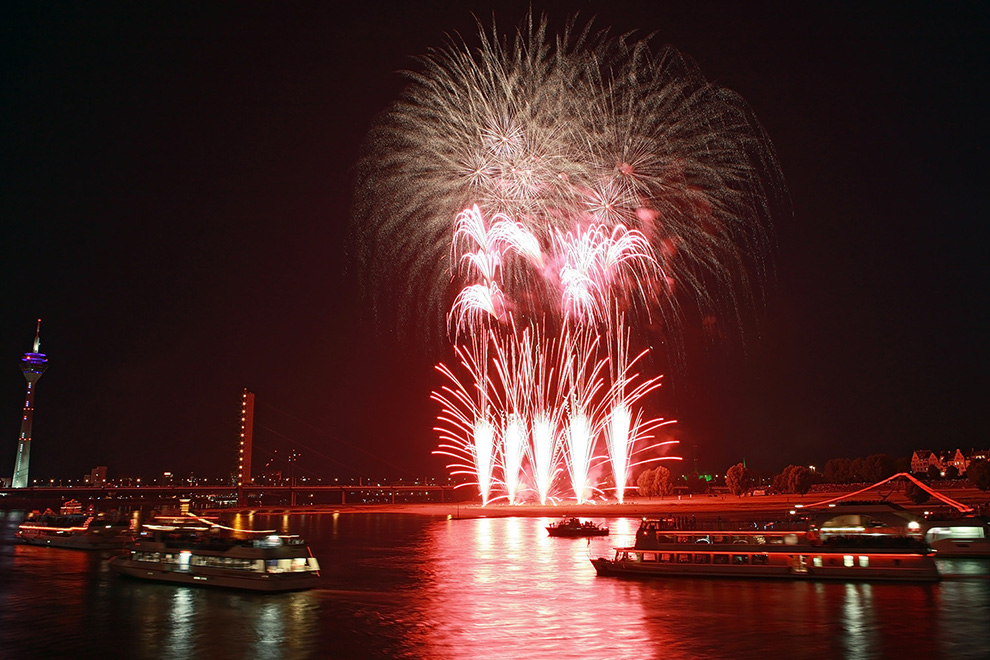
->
xmin=109 ymin=513 xmax=320 ymax=592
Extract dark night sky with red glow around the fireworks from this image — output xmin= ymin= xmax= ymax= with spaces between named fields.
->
xmin=0 ymin=0 xmax=990 ymax=478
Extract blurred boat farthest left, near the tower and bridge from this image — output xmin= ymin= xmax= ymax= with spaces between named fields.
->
xmin=15 ymin=501 xmax=134 ymax=550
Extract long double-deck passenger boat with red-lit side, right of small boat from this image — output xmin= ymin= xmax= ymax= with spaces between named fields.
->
xmin=591 ymin=520 xmax=939 ymax=581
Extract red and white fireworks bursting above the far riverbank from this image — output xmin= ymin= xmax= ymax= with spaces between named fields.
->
xmin=355 ymin=12 xmax=778 ymax=503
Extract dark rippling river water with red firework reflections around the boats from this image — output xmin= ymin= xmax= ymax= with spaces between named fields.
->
xmin=0 ymin=511 xmax=990 ymax=660
